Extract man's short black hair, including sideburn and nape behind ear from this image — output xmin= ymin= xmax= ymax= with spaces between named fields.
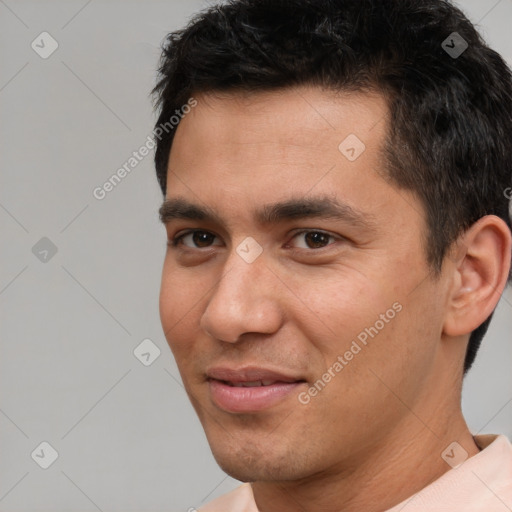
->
xmin=152 ymin=0 xmax=512 ymax=373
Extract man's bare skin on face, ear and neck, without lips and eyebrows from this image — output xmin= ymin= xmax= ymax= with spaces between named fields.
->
xmin=160 ymin=87 xmax=511 ymax=512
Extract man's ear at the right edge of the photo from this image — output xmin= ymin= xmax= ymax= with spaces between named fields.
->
xmin=443 ymin=215 xmax=512 ymax=336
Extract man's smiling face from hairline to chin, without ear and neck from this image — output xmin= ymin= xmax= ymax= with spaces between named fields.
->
xmin=160 ymin=88 xmax=447 ymax=481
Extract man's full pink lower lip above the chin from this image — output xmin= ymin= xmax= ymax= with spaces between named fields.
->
xmin=208 ymin=380 xmax=304 ymax=412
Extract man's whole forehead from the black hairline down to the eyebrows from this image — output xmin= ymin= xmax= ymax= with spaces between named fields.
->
xmin=167 ymin=87 xmax=424 ymax=234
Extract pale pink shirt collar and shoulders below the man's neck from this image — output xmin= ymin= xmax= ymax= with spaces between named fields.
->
xmin=199 ymin=434 xmax=512 ymax=512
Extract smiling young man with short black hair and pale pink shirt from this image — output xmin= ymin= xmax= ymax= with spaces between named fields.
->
xmin=155 ymin=0 xmax=512 ymax=512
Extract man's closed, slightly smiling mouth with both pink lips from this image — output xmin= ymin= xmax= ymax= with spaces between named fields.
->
xmin=207 ymin=367 xmax=306 ymax=413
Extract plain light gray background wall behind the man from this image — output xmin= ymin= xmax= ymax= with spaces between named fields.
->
xmin=0 ymin=0 xmax=512 ymax=512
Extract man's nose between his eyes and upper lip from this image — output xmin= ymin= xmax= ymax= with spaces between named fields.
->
xmin=200 ymin=246 xmax=284 ymax=343
